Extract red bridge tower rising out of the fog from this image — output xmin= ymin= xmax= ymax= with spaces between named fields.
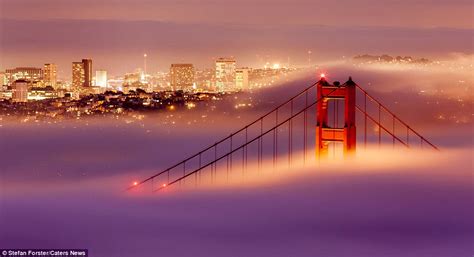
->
xmin=316 ymin=74 xmax=356 ymax=158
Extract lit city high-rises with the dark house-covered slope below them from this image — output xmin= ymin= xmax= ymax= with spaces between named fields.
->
xmin=0 ymin=54 xmax=299 ymax=102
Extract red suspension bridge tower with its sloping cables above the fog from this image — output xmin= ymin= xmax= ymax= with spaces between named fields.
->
xmin=127 ymin=74 xmax=438 ymax=192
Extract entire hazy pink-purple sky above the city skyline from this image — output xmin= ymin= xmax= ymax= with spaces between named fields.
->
xmin=0 ymin=0 xmax=473 ymax=77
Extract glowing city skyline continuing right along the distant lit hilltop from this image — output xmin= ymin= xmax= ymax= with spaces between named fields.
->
xmin=0 ymin=51 xmax=468 ymax=100
